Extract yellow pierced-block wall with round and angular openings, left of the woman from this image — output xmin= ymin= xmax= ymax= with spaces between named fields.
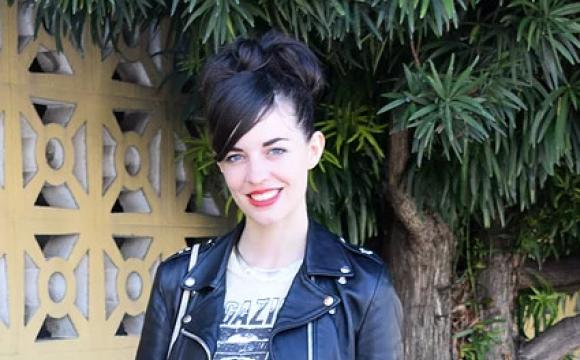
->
xmin=0 ymin=2 xmax=227 ymax=360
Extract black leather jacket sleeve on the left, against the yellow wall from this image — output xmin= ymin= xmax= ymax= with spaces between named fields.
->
xmin=135 ymin=263 xmax=175 ymax=360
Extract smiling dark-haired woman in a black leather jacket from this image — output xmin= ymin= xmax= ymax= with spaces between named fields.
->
xmin=137 ymin=32 xmax=402 ymax=360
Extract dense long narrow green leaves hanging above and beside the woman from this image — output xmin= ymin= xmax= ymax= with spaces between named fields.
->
xmin=22 ymin=0 xmax=580 ymax=233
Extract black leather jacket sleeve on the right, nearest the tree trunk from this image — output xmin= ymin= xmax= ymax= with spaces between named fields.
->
xmin=356 ymin=269 xmax=403 ymax=360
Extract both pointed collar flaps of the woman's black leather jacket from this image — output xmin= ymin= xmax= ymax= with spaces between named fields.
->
xmin=182 ymin=220 xmax=354 ymax=291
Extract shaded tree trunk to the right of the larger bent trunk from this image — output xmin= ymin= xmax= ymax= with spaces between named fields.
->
xmin=478 ymin=252 xmax=518 ymax=360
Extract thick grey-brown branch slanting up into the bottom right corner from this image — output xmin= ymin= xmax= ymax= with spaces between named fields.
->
xmin=520 ymin=315 xmax=580 ymax=360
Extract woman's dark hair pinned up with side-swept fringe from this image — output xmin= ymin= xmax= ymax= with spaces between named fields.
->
xmin=200 ymin=31 xmax=324 ymax=161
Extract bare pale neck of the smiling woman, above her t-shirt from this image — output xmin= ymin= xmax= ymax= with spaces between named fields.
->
xmin=238 ymin=202 xmax=308 ymax=269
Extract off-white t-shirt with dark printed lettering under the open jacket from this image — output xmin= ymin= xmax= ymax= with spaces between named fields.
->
xmin=214 ymin=250 xmax=302 ymax=360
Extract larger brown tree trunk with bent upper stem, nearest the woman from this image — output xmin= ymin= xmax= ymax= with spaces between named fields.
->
xmin=387 ymin=132 xmax=455 ymax=360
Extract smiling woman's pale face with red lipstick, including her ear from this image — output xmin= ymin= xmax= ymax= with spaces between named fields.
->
xmin=218 ymin=99 xmax=324 ymax=226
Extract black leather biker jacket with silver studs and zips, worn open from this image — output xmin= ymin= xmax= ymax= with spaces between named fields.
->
xmin=136 ymin=221 xmax=402 ymax=360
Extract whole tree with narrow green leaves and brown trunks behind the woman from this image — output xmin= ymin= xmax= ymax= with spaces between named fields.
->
xmin=21 ymin=0 xmax=580 ymax=359
